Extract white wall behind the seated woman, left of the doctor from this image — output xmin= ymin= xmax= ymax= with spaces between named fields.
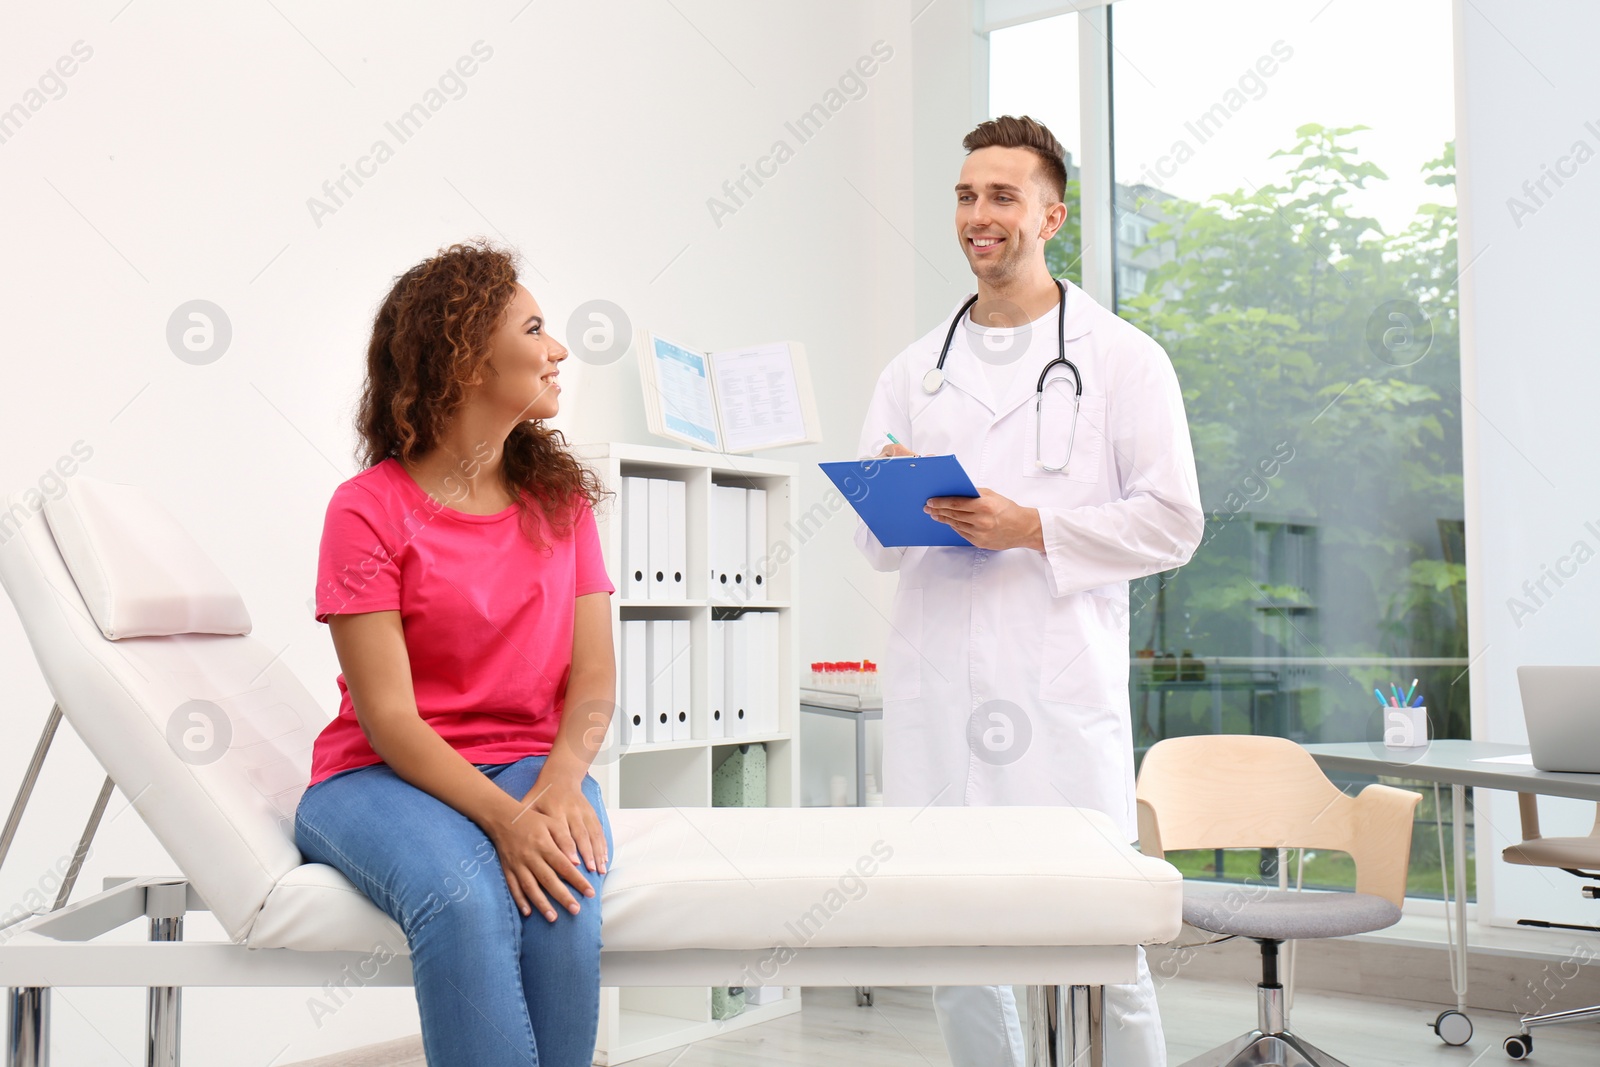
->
xmin=0 ymin=0 xmax=971 ymax=1067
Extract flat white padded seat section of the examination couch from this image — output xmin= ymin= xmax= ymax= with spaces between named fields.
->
xmin=248 ymin=808 xmax=1184 ymax=952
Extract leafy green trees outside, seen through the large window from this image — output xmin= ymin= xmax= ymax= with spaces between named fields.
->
xmin=1081 ymin=123 xmax=1469 ymax=886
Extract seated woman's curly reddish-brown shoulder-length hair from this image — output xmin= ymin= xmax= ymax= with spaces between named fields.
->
xmin=355 ymin=238 xmax=606 ymax=541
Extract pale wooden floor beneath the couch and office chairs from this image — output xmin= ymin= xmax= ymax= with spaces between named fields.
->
xmin=281 ymin=981 xmax=1600 ymax=1067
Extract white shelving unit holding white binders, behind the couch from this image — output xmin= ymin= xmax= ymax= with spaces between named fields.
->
xmin=573 ymin=443 xmax=800 ymax=1064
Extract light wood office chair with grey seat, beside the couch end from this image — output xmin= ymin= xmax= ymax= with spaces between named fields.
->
xmin=1138 ymin=734 xmax=1421 ymax=1067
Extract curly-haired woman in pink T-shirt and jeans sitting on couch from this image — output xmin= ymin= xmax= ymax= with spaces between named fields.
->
xmin=294 ymin=243 xmax=616 ymax=1067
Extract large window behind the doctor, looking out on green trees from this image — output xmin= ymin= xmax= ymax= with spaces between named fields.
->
xmin=990 ymin=0 xmax=1469 ymax=894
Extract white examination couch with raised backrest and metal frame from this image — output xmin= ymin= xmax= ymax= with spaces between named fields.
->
xmin=0 ymin=477 xmax=1182 ymax=1067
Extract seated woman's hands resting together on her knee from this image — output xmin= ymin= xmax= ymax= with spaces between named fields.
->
xmin=488 ymin=776 xmax=606 ymax=923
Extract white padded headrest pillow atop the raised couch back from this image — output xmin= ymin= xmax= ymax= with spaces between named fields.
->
xmin=45 ymin=475 xmax=250 ymax=641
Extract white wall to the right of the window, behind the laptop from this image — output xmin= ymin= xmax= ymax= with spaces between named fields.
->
xmin=1456 ymin=0 xmax=1600 ymax=923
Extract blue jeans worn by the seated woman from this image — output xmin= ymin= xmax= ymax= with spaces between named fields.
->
xmin=294 ymin=757 xmax=616 ymax=1067
